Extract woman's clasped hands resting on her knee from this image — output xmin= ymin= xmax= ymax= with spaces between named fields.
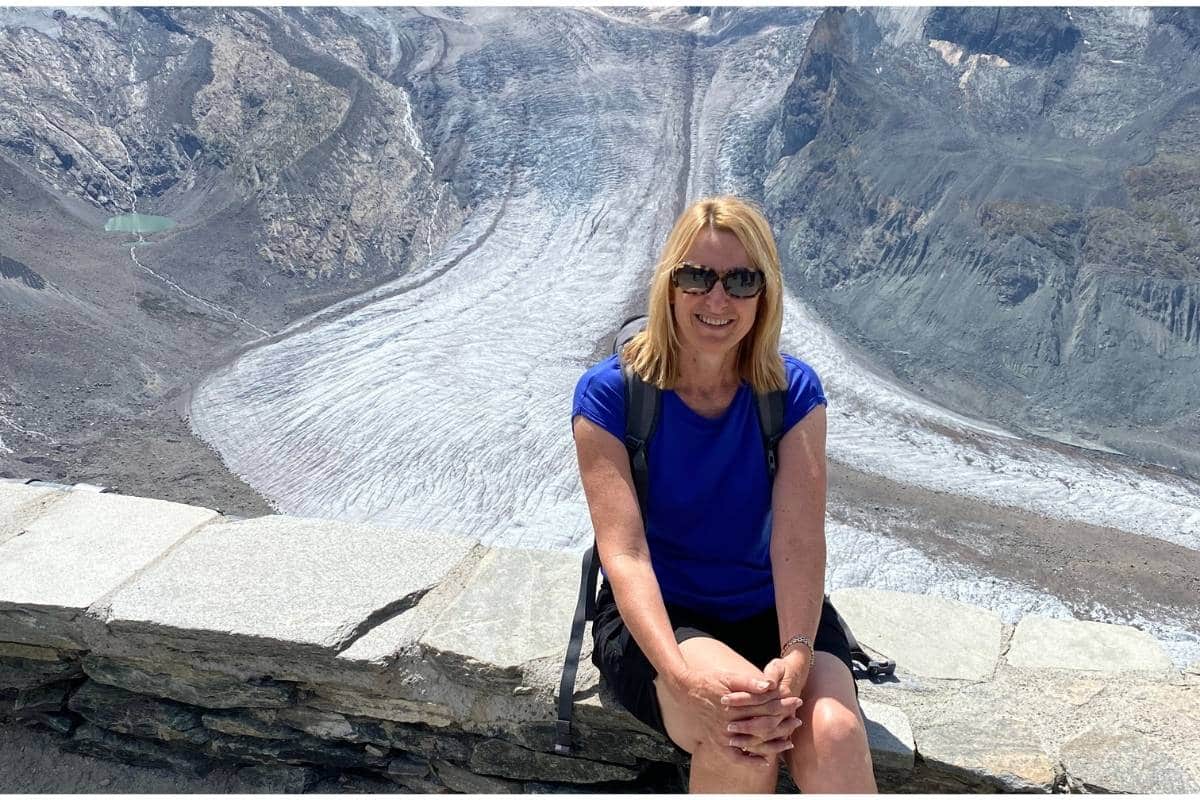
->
xmin=668 ymin=669 xmax=798 ymax=765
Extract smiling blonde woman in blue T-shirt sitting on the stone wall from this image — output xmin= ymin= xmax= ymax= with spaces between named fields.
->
xmin=572 ymin=197 xmax=875 ymax=793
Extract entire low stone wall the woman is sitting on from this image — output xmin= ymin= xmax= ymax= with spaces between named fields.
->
xmin=0 ymin=482 xmax=1200 ymax=793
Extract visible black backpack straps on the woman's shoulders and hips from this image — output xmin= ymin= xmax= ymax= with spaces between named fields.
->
xmin=554 ymin=314 xmax=895 ymax=756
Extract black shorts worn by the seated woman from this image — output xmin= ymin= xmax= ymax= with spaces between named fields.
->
xmin=592 ymin=581 xmax=858 ymax=735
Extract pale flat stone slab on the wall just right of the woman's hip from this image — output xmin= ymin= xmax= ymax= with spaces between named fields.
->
xmin=830 ymin=589 xmax=1003 ymax=680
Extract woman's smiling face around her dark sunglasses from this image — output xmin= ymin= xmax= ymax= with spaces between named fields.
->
xmin=671 ymin=225 xmax=761 ymax=362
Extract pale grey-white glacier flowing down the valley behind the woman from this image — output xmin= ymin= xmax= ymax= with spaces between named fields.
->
xmin=191 ymin=10 xmax=1200 ymax=663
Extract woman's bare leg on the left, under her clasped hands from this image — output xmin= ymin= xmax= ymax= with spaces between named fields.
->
xmin=654 ymin=637 xmax=777 ymax=794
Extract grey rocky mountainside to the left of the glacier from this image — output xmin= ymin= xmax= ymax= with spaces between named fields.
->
xmin=0 ymin=8 xmax=468 ymax=511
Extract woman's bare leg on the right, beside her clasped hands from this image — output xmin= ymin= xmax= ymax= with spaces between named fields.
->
xmin=785 ymin=651 xmax=877 ymax=794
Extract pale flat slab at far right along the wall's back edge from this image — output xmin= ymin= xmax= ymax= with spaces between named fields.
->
xmin=1007 ymin=614 xmax=1174 ymax=675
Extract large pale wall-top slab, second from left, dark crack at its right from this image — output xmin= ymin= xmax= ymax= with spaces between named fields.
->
xmin=96 ymin=516 xmax=474 ymax=655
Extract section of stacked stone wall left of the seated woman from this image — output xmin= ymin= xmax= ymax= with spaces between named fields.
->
xmin=0 ymin=485 xmax=679 ymax=793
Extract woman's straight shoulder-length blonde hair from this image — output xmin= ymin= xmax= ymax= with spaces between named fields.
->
xmin=622 ymin=194 xmax=787 ymax=392
